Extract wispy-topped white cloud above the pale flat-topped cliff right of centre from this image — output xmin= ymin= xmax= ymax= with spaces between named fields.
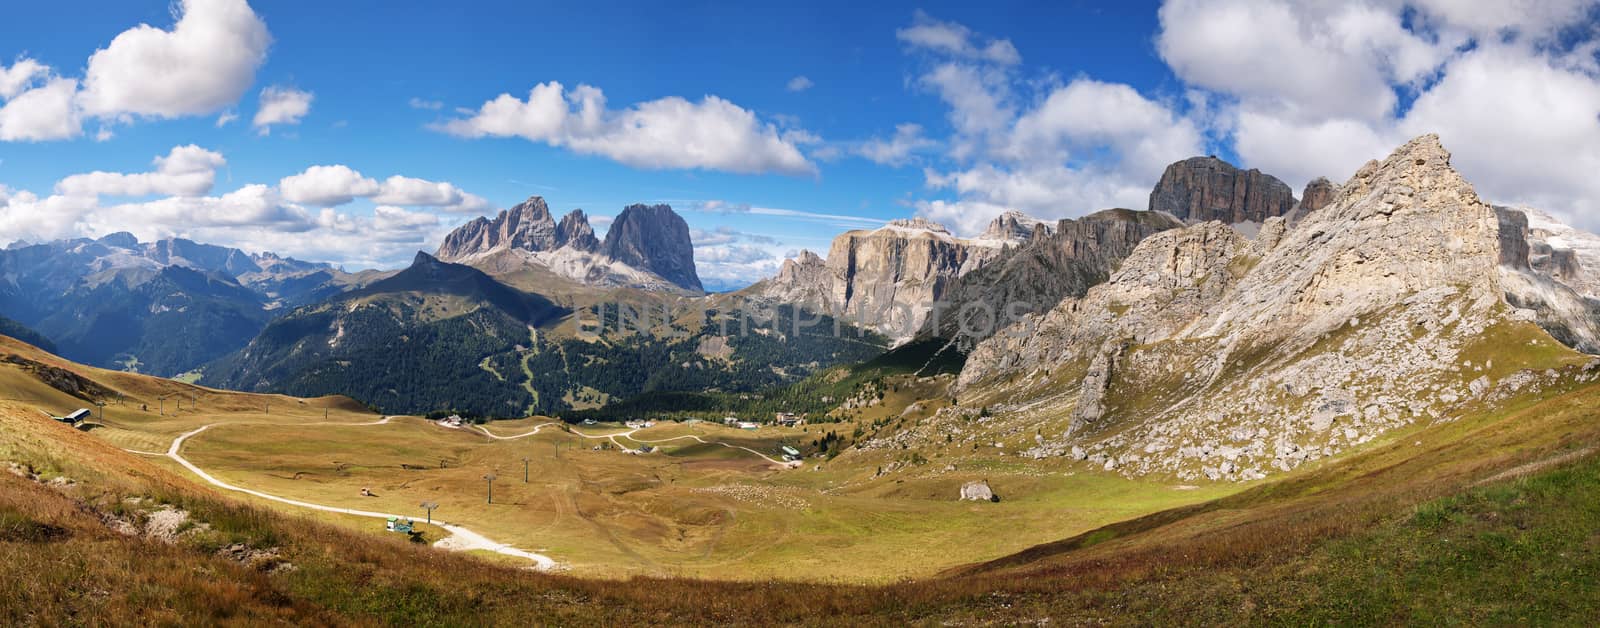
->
xmin=896 ymin=14 xmax=1205 ymax=234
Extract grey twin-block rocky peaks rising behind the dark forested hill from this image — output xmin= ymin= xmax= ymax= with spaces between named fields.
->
xmin=438 ymin=197 xmax=702 ymax=293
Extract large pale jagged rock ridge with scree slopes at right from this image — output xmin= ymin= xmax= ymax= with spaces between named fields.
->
xmin=957 ymin=136 xmax=1554 ymax=481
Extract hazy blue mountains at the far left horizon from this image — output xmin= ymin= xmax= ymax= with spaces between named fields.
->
xmin=0 ymin=234 xmax=381 ymax=375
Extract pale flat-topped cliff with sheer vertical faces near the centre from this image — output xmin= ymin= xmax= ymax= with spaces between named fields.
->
xmin=750 ymin=215 xmax=1030 ymax=340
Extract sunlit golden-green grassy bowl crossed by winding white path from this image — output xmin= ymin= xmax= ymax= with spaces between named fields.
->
xmin=99 ymin=415 xmax=1237 ymax=582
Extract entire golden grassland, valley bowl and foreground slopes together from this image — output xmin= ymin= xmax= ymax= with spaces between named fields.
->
xmin=0 ymin=333 xmax=1600 ymax=625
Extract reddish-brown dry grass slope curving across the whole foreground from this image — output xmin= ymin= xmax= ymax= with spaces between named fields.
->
xmin=0 ymin=333 xmax=1600 ymax=625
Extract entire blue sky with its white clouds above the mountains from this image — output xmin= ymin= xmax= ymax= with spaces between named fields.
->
xmin=0 ymin=0 xmax=1600 ymax=287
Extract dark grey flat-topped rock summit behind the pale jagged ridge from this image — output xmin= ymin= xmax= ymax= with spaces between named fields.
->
xmin=1149 ymin=157 xmax=1294 ymax=224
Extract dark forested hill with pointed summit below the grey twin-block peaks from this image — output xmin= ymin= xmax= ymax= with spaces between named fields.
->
xmin=205 ymin=248 xmax=888 ymax=417
